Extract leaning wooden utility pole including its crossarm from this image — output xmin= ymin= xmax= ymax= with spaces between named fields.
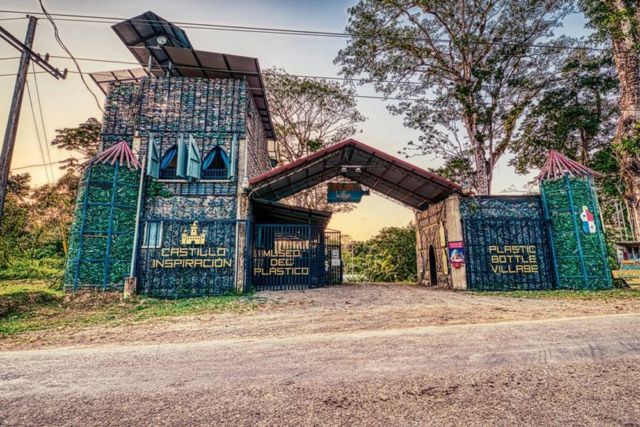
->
xmin=0 ymin=16 xmax=67 ymax=223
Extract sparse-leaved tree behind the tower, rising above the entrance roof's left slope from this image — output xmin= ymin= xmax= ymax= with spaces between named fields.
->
xmin=265 ymin=68 xmax=365 ymax=210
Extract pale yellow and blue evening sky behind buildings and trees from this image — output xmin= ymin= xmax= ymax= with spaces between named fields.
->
xmin=0 ymin=0 xmax=585 ymax=240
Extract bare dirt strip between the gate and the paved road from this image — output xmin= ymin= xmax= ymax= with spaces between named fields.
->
xmin=5 ymin=285 xmax=640 ymax=351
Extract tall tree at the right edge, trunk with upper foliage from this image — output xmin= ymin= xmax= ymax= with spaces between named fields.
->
xmin=580 ymin=0 xmax=640 ymax=239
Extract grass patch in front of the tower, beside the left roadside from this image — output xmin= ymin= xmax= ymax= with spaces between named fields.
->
xmin=0 ymin=281 xmax=264 ymax=337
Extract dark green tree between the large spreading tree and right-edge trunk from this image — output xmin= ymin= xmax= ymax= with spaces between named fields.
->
xmin=510 ymin=50 xmax=618 ymax=173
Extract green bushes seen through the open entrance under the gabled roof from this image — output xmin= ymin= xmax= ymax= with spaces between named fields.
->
xmin=343 ymin=225 xmax=417 ymax=282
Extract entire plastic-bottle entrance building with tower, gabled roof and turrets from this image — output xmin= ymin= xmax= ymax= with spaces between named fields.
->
xmin=65 ymin=12 xmax=611 ymax=298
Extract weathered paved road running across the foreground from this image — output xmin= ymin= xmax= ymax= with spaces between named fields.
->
xmin=0 ymin=284 xmax=640 ymax=426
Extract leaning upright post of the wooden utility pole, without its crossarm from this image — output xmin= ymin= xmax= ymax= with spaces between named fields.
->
xmin=0 ymin=16 xmax=37 ymax=222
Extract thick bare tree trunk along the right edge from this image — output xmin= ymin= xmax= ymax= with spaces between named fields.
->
xmin=612 ymin=0 xmax=640 ymax=240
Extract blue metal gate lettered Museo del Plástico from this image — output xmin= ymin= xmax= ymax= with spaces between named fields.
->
xmin=251 ymin=224 xmax=342 ymax=290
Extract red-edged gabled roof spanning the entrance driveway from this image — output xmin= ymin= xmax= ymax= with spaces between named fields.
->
xmin=249 ymin=139 xmax=462 ymax=210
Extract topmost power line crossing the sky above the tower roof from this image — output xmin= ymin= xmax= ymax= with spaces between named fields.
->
xmin=0 ymin=8 xmax=607 ymax=51
